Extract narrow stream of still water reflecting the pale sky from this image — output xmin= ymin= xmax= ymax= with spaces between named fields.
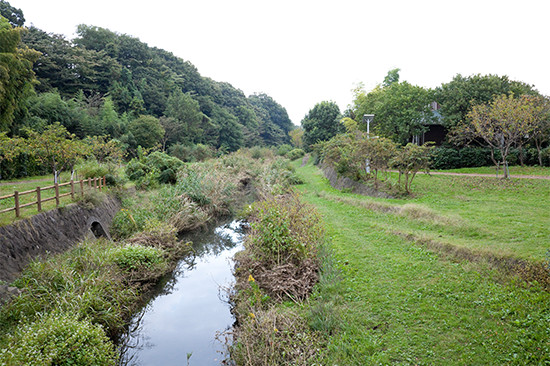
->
xmin=121 ymin=221 xmax=243 ymax=366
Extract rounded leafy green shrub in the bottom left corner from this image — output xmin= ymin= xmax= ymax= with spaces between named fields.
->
xmin=0 ymin=313 xmax=117 ymax=366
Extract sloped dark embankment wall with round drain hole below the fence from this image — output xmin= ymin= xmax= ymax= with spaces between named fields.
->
xmin=0 ymin=196 xmax=120 ymax=283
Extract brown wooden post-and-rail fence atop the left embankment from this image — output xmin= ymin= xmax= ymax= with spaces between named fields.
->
xmin=0 ymin=177 xmax=106 ymax=217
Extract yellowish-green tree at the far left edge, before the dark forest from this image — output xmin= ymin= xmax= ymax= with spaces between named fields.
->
xmin=0 ymin=16 xmax=39 ymax=131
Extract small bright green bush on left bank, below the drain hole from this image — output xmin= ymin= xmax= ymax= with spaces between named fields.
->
xmin=110 ymin=245 xmax=164 ymax=271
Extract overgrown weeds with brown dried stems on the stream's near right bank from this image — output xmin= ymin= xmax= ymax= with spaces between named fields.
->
xmin=230 ymin=193 xmax=330 ymax=365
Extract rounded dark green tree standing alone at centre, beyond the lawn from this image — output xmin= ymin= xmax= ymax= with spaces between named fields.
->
xmin=302 ymin=101 xmax=343 ymax=148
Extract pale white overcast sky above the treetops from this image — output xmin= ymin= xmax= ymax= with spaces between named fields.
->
xmin=8 ymin=0 xmax=550 ymax=124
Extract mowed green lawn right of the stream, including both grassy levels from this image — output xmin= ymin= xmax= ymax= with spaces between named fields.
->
xmin=298 ymin=165 xmax=550 ymax=365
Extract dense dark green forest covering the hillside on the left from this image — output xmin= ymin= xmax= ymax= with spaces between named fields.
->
xmin=0 ymin=1 xmax=293 ymax=159
